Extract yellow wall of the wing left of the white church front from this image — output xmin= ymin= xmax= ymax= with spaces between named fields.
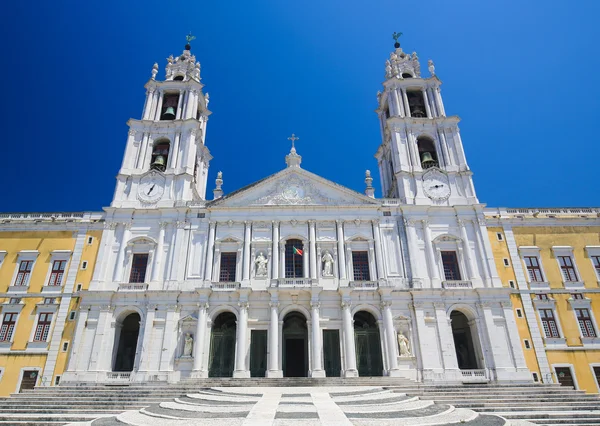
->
xmin=0 ymin=230 xmax=102 ymax=396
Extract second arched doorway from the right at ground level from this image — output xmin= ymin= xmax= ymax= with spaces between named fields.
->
xmin=354 ymin=311 xmax=383 ymax=376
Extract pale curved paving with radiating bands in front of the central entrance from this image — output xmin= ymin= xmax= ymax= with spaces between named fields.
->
xmin=64 ymin=386 xmax=531 ymax=426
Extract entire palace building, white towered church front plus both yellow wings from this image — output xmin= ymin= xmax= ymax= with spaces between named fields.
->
xmin=0 ymin=38 xmax=600 ymax=393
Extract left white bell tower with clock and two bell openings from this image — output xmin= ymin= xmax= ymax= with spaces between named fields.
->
xmin=111 ymin=35 xmax=212 ymax=208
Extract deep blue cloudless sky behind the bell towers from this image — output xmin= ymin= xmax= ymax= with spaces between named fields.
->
xmin=0 ymin=0 xmax=600 ymax=211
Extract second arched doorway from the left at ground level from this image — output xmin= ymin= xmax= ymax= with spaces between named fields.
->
xmin=208 ymin=312 xmax=236 ymax=377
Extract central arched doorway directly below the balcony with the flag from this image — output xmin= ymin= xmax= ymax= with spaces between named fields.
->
xmin=283 ymin=312 xmax=308 ymax=377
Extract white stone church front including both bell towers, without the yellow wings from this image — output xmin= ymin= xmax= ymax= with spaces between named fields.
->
xmin=62 ymin=41 xmax=531 ymax=383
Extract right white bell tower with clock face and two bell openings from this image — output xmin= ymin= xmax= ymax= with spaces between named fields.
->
xmin=375 ymin=33 xmax=478 ymax=205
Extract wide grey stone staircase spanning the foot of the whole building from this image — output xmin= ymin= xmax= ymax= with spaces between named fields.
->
xmin=0 ymin=377 xmax=600 ymax=426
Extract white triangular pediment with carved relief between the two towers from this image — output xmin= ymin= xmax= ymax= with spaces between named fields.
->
xmin=211 ymin=167 xmax=379 ymax=207
